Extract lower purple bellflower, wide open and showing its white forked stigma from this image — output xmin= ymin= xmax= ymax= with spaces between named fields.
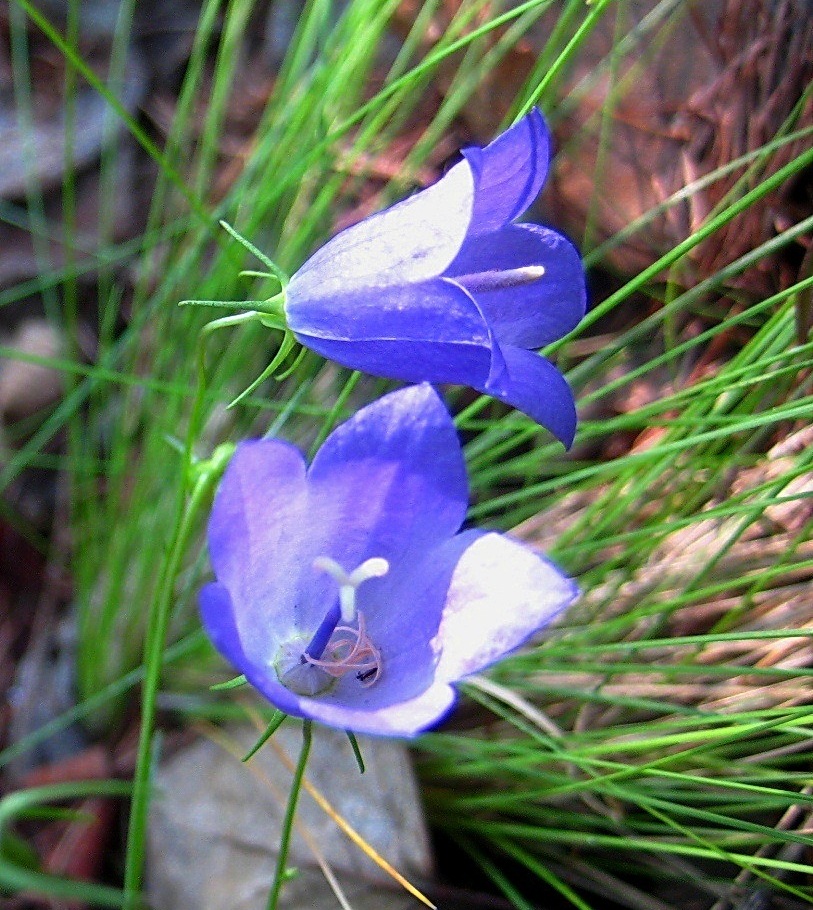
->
xmin=200 ymin=384 xmax=577 ymax=736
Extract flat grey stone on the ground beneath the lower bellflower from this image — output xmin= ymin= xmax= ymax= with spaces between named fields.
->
xmin=147 ymin=720 xmax=432 ymax=910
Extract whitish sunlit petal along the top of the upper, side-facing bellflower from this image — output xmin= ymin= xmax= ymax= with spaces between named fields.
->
xmin=286 ymin=162 xmax=474 ymax=302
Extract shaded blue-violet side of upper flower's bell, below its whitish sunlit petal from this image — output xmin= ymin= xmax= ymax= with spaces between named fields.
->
xmin=289 ymin=278 xmax=494 ymax=385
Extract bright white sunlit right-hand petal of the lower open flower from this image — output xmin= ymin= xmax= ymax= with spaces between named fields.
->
xmin=436 ymin=534 xmax=578 ymax=682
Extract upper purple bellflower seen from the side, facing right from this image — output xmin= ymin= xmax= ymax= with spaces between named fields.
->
xmin=285 ymin=108 xmax=585 ymax=446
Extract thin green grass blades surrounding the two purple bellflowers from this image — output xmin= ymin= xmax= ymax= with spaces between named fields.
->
xmin=0 ymin=0 xmax=813 ymax=910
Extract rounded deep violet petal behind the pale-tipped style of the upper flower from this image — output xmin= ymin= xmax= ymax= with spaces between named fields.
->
xmin=447 ymin=224 xmax=586 ymax=348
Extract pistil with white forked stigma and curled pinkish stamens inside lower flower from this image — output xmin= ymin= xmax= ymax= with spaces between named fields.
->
xmin=275 ymin=556 xmax=390 ymax=695
